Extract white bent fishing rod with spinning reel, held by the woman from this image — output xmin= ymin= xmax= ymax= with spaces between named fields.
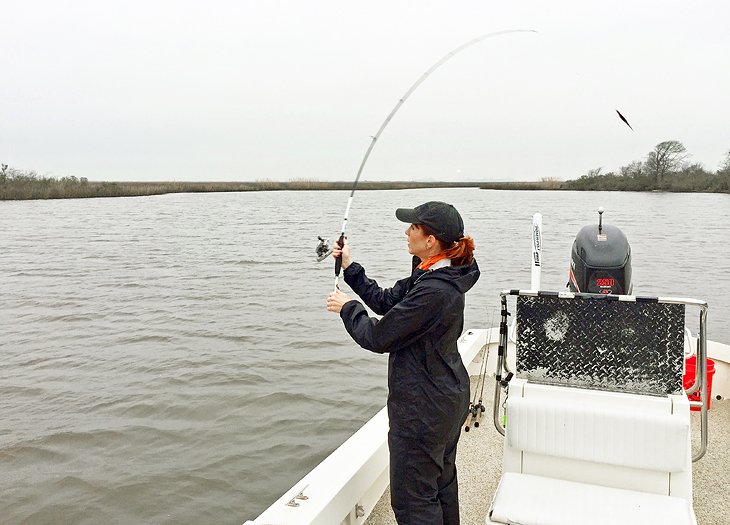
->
xmin=316 ymin=29 xmax=537 ymax=291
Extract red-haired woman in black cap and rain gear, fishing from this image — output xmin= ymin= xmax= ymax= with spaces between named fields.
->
xmin=327 ymin=201 xmax=479 ymax=525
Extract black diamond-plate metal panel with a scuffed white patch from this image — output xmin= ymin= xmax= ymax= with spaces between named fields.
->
xmin=517 ymin=296 xmax=685 ymax=395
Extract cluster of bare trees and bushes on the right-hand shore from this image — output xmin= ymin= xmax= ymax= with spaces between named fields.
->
xmin=561 ymin=140 xmax=730 ymax=193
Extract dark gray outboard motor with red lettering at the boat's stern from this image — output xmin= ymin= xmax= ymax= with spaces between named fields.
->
xmin=568 ymin=208 xmax=633 ymax=295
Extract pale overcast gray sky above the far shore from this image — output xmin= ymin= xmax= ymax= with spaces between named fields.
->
xmin=0 ymin=0 xmax=730 ymax=181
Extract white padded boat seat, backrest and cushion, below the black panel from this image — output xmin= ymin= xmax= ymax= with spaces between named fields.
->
xmin=486 ymin=378 xmax=696 ymax=525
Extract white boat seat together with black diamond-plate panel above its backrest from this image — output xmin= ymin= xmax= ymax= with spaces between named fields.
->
xmin=486 ymin=291 xmax=696 ymax=525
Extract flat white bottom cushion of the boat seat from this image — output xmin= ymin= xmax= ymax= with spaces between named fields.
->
xmin=487 ymin=472 xmax=697 ymax=525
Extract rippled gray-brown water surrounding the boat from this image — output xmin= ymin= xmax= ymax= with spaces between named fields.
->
xmin=0 ymin=189 xmax=730 ymax=524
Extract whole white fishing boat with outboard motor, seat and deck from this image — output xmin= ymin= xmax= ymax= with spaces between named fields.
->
xmin=245 ymin=214 xmax=730 ymax=525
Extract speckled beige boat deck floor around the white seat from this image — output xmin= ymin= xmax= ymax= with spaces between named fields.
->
xmin=366 ymin=377 xmax=730 ymax=525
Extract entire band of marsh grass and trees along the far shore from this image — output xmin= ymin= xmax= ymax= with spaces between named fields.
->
xmin=0 ymin=140 xmax=730 ymax=200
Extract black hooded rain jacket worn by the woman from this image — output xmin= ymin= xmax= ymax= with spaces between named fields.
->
xmin=340 ymin=257 xmax=479 ymax=443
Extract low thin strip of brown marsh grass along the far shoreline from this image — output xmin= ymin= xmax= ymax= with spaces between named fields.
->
xmin=0 ymin=178 xmax=727 ymax=200
